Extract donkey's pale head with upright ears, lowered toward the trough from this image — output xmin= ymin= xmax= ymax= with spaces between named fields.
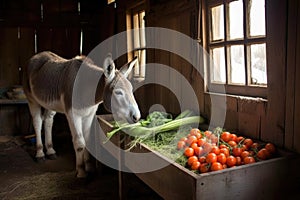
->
xmin=103 ymin=55 xmax=141 ymax=123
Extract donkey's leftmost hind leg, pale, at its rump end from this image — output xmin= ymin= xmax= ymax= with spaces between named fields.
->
xmin=28 ymin=100 xmax=45 ymax=162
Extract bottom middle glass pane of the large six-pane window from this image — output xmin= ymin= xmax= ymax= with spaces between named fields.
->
xmin=229 ymin=45 xmax=246 ymax=84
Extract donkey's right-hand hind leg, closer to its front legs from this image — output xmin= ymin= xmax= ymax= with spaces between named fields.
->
xmin=44 ymin=110 xmax=56 ymax=160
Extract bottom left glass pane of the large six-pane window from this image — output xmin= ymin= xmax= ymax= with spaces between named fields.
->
xmin=210 ymin=47 xmax=226 ymax=83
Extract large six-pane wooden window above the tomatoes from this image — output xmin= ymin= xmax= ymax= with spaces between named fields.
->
xmin=205 ymin=0 xmax=267 ymax=97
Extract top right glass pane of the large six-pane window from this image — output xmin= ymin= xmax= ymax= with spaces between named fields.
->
xmin=249 ymin=0 xmax=266 ymax=36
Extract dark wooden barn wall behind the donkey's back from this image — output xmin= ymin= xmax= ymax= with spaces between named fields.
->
xmin=0 ymin=0 xmax=114 ymax=87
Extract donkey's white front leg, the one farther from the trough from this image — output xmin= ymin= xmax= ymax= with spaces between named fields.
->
xmin=67 ymin=114 xmax=86 ymax=178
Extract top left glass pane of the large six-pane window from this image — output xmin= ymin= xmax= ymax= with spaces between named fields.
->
xmin=211 ymin=5 xmax=224 ymax=41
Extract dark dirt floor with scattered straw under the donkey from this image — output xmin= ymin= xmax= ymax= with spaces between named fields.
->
xmin=0 ymin=133 xmax=161 ymax=200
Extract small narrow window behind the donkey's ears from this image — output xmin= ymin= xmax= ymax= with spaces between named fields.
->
xmin=127 ymin=6 xmax=146 ymax=81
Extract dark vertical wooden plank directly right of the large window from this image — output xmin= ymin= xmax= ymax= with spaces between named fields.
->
xmin=261 ymin=0 xmax=287 ymax=146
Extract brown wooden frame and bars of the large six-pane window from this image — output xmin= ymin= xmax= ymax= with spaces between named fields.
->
xmin=202 ymin=0 xmax=268 ymax=98
